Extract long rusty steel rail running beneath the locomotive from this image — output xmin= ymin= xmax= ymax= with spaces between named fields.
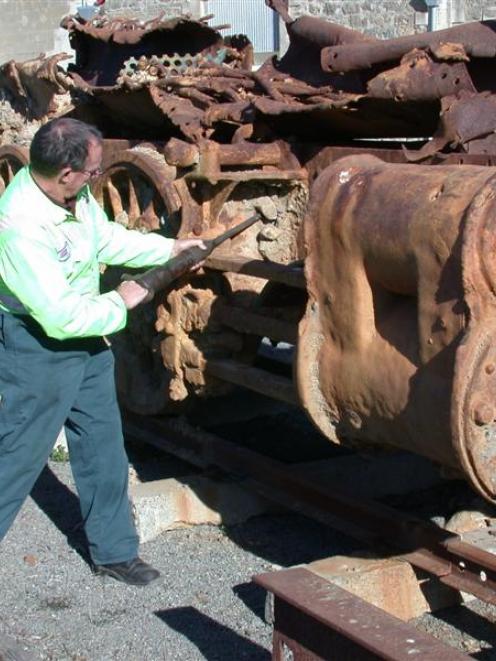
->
xmin=125 ymin=416 xmax=496 ymax=604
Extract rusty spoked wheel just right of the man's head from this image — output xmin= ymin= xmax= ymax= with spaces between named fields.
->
xmin=93 ymin=146 xmax=181 ymax=238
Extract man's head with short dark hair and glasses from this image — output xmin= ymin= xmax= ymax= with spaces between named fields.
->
xmin=30 ymin=117 xmax=102 ymax=199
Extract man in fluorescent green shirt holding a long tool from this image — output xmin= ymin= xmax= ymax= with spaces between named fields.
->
xmin=0 ymin=118 xmax=203 ymax=585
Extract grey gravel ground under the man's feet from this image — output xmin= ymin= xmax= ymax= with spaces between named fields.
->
xmin=0 ymin=430 xmax=496 ymax=661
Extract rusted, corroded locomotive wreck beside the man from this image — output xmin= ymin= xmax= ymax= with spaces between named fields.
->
xmin=0 ymin=0 xmax=496 ymax=501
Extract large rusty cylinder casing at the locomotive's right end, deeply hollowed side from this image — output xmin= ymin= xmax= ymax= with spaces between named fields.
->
xmin=297 ymin=155 xmax=496 ymax=500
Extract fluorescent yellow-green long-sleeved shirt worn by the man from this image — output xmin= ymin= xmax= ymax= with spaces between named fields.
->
xmin=0 ymin=166 xmax=174 ymax=339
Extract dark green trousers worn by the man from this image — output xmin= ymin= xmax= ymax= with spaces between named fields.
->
xmin=0 ymin=312 xmax=138 ymax=564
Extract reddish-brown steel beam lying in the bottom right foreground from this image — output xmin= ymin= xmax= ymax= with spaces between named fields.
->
xmin=253 ymin=568 xmax=470 ymax=661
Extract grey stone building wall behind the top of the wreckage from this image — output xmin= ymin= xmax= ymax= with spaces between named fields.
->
xmin=0 ymin=0 xmax=490 ymax=63
